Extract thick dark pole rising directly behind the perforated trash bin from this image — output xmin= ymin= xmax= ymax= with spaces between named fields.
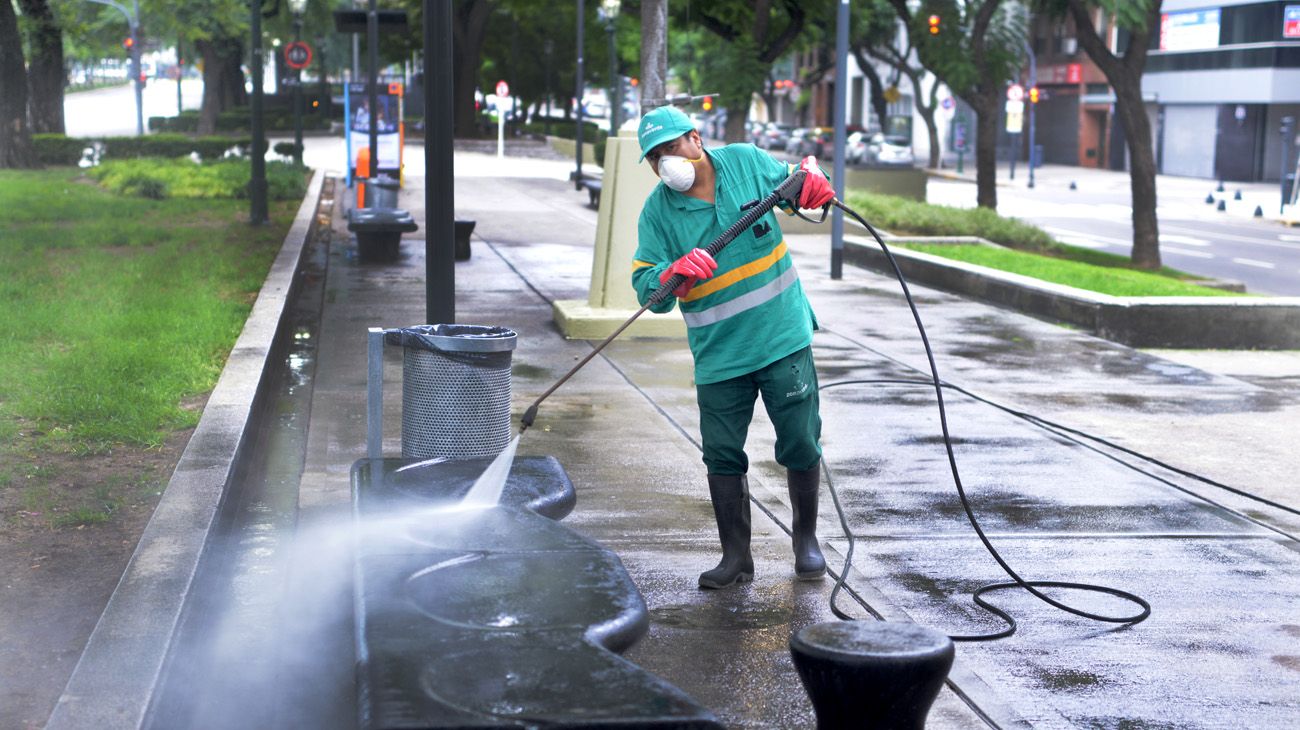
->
xmin=424 ymin=0 xmax=456 ymax=325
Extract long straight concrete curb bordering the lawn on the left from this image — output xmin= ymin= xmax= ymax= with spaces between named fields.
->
xmin=46 ymin=170 xmax=325 ymax=730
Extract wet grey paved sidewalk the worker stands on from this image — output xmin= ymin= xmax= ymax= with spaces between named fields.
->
xmin=299 ymin=146 xmax=1300 ymax=727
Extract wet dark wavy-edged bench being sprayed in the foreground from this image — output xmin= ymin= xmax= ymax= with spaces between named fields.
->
xmin=352 ymin=456 xmax=722 ymax=730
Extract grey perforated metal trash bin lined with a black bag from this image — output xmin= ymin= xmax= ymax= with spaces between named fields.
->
xmin=384 ymin=325 xmax=519 ymax=459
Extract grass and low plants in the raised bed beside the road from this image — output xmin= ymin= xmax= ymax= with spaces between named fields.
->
xmin=849 ymin=192 xmax=1243 ymax=296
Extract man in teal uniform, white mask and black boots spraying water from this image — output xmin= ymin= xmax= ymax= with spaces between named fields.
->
xmin=632 ymin=107 xmax=835 ymax=588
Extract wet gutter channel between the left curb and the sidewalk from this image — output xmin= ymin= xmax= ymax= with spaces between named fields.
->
xmin=146 ymin=181 xmax=338 ymax=727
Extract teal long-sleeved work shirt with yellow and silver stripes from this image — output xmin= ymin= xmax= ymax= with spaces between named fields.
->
xmin=632 ymin=144 xmax=816 ymax=383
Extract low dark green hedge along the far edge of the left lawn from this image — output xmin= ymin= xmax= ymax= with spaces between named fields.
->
xmin=33 ymin=134 xmax=252 ymax=165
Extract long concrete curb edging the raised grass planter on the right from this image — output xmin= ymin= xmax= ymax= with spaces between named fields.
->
xmin=844 ymin=232 xmax=1300 ymax=349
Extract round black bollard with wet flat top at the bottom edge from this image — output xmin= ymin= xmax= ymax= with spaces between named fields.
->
xmin=790 ymin=621 xmax=956 ymax=730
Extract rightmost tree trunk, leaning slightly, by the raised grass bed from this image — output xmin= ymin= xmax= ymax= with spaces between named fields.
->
xmin=1110 ymin=75 xmax=1160 ymax=269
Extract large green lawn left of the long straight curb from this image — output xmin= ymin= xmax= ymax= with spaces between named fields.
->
xmin=0 ymin=162 xmax=300 ymax=526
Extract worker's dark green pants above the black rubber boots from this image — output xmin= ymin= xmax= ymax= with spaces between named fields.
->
xmin=696 ymin=346 xmax=822 ymax=474
